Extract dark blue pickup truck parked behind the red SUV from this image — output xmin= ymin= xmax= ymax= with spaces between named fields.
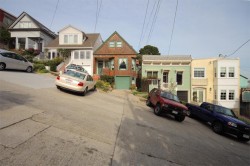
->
xmin=186 ymin=102 xmax=250 ymax=142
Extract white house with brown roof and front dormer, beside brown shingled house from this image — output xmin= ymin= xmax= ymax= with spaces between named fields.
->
xmin=45 ymin=25 xmax=103 ymax=75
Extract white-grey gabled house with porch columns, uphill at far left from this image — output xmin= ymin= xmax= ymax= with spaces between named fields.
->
xmin=9 ymin=12 xmax=56 ymax=52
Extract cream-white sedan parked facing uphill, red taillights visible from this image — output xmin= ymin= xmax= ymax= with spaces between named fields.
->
xmin=55 ymin=70 xmax=96 ymax=95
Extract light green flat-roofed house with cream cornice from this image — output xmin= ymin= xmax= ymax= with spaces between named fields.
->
xmin=141 ymin=55 xmax=192 ymax=102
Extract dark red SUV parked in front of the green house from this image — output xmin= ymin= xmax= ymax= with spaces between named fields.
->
xmin=146 ymin=88 xmax=188 ymax=122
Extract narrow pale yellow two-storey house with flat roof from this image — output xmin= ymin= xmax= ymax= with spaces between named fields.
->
xmin=190 ymin=58 xmax=216 ymax=104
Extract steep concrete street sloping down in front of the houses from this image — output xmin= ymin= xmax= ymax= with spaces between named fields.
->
xmin=0 ymin=71 xmax=250 ymax=166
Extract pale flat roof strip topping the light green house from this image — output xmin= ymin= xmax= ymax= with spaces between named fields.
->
xmin=142 ymin=55 xmax=192 ymax=61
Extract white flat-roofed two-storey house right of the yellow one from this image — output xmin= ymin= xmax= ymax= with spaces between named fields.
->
xmin=213 ymin=57 xmax=240 ymax=113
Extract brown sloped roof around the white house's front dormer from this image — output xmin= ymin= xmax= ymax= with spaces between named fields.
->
xmin=45 ymin=33 xmax=100 ymax=48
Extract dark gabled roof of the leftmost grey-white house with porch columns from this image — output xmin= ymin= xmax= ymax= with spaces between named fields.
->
xmin=9 ymin=12 xmax=56 ymax=38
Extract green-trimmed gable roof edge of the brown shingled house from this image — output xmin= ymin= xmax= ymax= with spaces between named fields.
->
xmin=94 ymin=31 xmax=137 ymax=55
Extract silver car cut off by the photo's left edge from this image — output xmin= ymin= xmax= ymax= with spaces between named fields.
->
xmin=0 ymin=49 xmax=33 ymax=73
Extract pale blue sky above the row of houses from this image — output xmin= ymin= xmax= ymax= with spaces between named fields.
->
xmin=0 ymin=0 xmax=250 ymax=79
